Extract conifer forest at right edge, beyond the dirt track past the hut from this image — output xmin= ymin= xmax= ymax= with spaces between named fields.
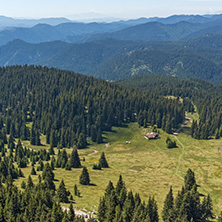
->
xmin=120 ymin=75 xmax=222 ymax=139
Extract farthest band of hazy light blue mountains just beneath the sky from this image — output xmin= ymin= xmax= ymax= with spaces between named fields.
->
xmin=0 ymin=15 xmax=222 ymax=45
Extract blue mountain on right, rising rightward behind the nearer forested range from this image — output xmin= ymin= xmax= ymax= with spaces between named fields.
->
xmin=84 ymin=21 xmax=222 ymax=41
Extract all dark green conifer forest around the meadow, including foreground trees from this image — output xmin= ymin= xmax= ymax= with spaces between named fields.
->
xmin=0 ymin=66 xmax=222 ymax=222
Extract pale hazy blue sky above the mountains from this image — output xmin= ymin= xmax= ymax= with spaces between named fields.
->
xmin=0 ymin=0 xmax=222 ymax=19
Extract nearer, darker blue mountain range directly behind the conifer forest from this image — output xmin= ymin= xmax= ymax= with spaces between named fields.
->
xmin=0 ymin=35 xmax=222 ymax=83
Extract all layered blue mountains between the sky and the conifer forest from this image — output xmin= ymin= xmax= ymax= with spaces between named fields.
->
xmin=0 ymin=15 xmax=222 ymax=83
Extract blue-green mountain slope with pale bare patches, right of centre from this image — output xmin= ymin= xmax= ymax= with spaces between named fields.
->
xmin=92 ymin=49 xmax=222 ymax=83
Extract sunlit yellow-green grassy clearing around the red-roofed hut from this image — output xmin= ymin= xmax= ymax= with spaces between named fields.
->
xmin=15 ymin=119 xmax=222 ymax=219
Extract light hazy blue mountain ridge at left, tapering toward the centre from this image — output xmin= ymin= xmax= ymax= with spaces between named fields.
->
xmin=0 ymin=22 xmax=128 ymax=45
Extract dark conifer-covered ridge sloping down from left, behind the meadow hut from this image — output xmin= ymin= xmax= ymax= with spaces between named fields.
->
xmin=0 ymin=66 xmax=185 ymax=148
